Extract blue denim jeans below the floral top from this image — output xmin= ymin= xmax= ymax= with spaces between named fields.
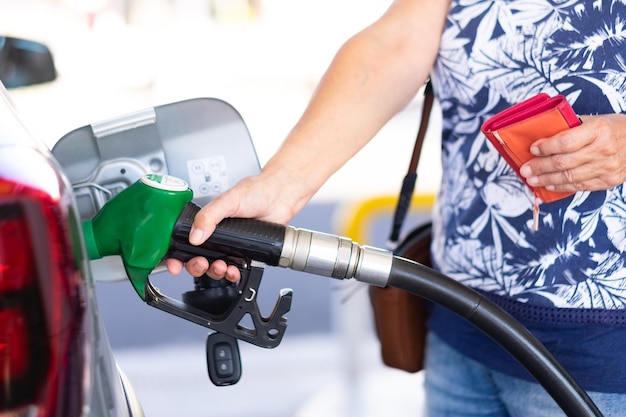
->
xmin=424 ymin=333 xmax=626 ymax=417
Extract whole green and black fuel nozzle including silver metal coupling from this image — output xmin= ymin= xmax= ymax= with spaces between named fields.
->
xmin=83 ymin=174 xmax=392 ymax=348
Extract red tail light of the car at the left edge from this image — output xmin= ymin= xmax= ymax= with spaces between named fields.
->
xmin=0 ymin=178 xmax=85 ymax=417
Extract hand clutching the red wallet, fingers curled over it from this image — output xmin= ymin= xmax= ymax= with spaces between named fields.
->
xmin=520 ymin=114 xmax=626 ymax=192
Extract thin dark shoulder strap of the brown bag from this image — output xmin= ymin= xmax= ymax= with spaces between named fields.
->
xmin=387 ymin=80 xmax=435 ymax=249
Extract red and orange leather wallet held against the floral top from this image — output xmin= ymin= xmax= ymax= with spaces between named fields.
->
xmin=481 ymin=93 xmax=581 ymax=230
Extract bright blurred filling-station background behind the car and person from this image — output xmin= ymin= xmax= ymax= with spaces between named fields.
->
xmin=0 ymin=0 xmax=440 ymax=417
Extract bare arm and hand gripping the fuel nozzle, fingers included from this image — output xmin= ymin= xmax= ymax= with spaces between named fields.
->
xmin=168 ymin=0 xmax=449 ymax=281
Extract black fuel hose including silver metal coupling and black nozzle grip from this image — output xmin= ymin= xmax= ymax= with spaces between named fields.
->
xmin=172 ymin=203 xmax=602 ymax=417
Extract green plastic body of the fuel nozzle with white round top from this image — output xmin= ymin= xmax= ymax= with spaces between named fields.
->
xmin=83 ymin=174 xmax=193 ymax=301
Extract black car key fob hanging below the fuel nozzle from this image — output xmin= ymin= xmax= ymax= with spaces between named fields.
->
xmin=206 ymin=332 xmax=241 ymax=387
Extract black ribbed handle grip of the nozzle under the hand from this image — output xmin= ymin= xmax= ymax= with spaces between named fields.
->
xmin=172 ymin=203 xmax=286 ymax=266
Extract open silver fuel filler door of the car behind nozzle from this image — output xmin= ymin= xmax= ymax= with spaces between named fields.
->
xmin=52 ymin=98 xmax=260 ymax=281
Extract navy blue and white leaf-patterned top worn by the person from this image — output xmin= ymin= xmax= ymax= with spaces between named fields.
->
xmin=430 ymin=0 xmax=626 ymax=392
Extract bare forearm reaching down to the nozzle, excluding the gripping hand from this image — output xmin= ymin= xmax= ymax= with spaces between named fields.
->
xmin=261 ymin=0 xmax=447 ymax=211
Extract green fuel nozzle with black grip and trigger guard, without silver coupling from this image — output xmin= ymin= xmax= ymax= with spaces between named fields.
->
xmin=83 ymin=174 xmax=292 ymax=348
